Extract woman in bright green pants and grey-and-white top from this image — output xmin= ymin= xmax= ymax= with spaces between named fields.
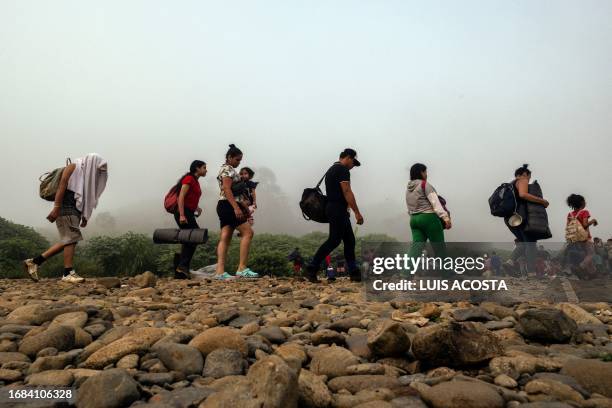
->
xmin=406 ymin=163 xmax=452 ymax=257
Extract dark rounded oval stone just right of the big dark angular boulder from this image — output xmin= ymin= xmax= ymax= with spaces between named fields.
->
xmin=517 ymin=308 xmax=577 ymax=343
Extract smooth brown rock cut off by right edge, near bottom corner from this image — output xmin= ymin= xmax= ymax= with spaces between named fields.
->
xmin=561 ymin=358 xmax=612 ymax=398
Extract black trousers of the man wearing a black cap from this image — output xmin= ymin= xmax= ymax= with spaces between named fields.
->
xmin=309 ymin=203 xmax=357 ymax=275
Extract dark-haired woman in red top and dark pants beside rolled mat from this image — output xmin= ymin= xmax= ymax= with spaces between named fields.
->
xmin=174 ymin=160 xmax=207 ymax=279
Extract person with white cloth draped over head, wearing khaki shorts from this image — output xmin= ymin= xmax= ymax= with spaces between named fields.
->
xmin=23 ymin=153 xmax=108 ymax=283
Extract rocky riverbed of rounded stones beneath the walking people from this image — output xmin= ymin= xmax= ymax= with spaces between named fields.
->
xmin=0 ymin=273 xmax=612 ymax=408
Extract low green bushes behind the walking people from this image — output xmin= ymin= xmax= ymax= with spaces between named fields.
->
xmin=0 ymin=217 xmax=394 ymax=278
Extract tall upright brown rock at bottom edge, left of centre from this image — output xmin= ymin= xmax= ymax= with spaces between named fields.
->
xmin=247 ymin=355 xmax=299 ymax=408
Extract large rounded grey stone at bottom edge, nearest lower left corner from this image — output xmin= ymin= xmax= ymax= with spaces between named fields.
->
xmin=76 ymin=368 xmax=140 ymax=408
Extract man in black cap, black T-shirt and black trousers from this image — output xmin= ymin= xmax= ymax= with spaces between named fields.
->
xmin=306 ymin=148 xmax=363 ymax=282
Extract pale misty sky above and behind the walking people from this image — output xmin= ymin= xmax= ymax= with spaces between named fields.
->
xmin=0 ymin=0 xmax=612 ymax=241
